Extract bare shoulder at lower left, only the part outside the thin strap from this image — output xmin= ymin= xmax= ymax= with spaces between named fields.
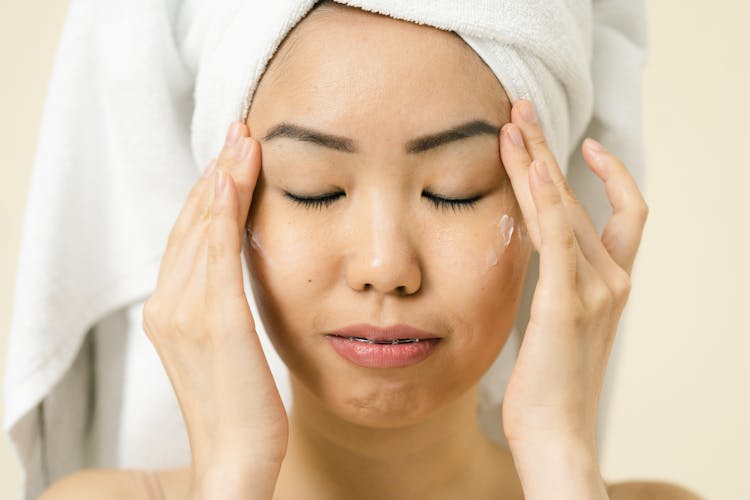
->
xmin=39 ymin=469 xmax=146 ymax=500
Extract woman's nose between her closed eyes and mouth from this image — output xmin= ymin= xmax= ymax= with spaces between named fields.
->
xmin=346 ymin=197 xmax=422 ymax=295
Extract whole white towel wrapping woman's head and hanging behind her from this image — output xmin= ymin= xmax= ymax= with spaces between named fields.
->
xmin=4 ymin=0 xmax=645 ymax=498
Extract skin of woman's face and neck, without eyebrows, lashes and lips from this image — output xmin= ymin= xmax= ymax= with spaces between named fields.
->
xmin=245 ymin=5 xmax=531 ymax=498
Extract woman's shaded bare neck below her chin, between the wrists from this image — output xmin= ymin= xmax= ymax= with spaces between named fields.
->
xmin=277 ymin=380 xmax=505 ymax=499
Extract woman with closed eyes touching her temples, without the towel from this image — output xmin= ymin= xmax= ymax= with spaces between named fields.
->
xmin=43 ymin=4 xmax=697 ymax=500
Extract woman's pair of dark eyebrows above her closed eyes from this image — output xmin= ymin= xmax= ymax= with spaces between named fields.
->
xmin=263 ymin=120 xmax=500 ymax=154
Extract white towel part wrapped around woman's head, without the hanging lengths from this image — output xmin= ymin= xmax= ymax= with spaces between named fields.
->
xmin=192 ymin=0 xmax=594 ymax=170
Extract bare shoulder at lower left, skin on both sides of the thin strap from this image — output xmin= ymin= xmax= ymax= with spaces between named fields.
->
xmin=39 ymin=468 xmax=189 ymax=500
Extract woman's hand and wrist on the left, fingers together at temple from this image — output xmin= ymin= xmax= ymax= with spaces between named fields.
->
xmin=143 ymin=123 xmax=288 ymax=500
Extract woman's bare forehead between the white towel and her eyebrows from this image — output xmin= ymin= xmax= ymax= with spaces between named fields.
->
xmin=250 ymin=6 xmax=509 ymax=131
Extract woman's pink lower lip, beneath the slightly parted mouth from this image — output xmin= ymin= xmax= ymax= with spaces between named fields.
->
xmin=326 ymin=335 xmax=440 ymax=368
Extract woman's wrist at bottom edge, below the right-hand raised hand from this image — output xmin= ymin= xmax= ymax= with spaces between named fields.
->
xmin=509 ymin=436 xmax=609 ymax=500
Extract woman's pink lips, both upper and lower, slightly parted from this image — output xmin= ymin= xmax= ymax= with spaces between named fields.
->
xmin=326 ymin=324 xmax=441 ymax=368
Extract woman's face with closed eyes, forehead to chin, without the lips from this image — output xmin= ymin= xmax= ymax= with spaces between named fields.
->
xmin=244 ymin=2 xmax=531 ymax=427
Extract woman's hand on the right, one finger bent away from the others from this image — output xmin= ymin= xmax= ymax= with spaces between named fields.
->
xmin=500 ymin=101 xmax=648 ymax=496
